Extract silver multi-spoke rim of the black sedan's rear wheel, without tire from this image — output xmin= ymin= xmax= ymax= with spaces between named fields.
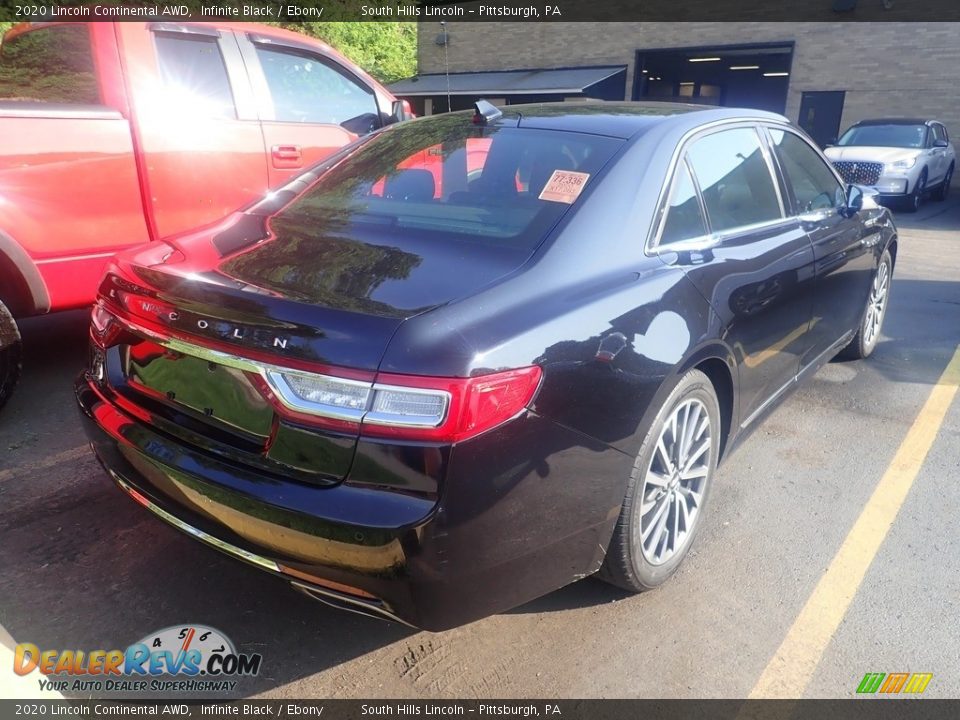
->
xmin=640 ymin=399 xmax=713 ymax=565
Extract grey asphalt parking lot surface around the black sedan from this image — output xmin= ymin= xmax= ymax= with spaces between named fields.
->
xmin=0 ymin=193 xmax=960 ymax=698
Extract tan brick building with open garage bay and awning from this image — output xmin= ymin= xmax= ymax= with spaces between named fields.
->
xmin=394 ymin=22 xmax=960 ymax=143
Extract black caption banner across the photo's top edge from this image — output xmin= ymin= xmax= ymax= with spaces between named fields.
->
xmin=0 ymin=0 xmax=960 ymax=22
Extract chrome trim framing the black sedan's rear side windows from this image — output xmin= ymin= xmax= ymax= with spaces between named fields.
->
xmin=643 ymin=118 xmax=795 ymax=256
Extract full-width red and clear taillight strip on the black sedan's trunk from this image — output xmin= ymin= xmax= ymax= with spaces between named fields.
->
xmin=91 ymin=289 xmax=542 ymax=443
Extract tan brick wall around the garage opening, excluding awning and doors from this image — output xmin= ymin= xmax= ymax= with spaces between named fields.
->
xmin=419 ymin=22 xmax=960 ymax=140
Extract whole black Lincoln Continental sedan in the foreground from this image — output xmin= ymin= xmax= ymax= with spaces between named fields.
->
xmin=77 ymin=101 xmax=897 ymax=630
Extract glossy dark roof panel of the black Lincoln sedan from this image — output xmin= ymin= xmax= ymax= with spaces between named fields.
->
xmin=476 ymin=101 xmax=788 ymax=139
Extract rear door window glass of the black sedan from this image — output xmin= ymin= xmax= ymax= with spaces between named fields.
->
xmin=688 ymin=128 xmax=783 ymax=232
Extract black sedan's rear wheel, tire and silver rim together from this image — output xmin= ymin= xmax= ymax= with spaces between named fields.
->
xmin=599 ymin=370 xmax=721 ymax=592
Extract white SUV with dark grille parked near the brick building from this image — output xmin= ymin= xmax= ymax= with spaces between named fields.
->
xmin=824 ymin=119 xmax=957 ymax=212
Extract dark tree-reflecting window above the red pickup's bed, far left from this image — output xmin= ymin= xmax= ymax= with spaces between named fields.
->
xmin=0 ymin=24 xmax=100 ymax=105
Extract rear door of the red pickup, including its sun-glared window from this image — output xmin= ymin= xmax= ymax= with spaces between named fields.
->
xmin=121 ymin=22 xmax=269 ymax=238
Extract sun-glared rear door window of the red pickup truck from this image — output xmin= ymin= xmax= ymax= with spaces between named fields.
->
xmin=156 ymin=35 xmax=237 ymax=119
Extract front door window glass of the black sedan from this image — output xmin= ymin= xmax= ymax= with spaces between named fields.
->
xmin=770 ymin=129 xmax=846 ymax=214
